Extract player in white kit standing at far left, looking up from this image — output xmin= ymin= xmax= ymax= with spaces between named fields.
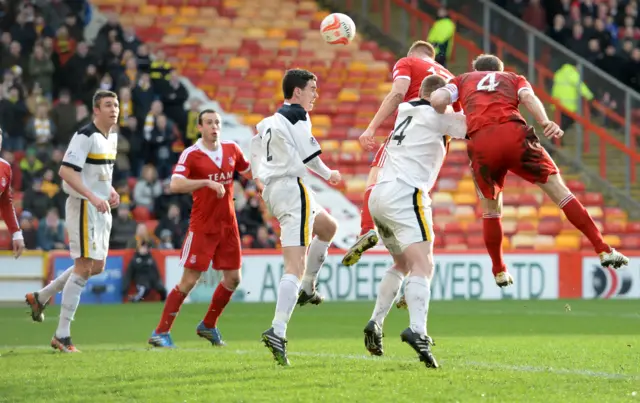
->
xmin=25 ymin=90 xmax=120 ymax=353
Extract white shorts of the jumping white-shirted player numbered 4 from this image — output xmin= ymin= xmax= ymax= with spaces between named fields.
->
xmin=369 ymin=181 xmax=435 ymax=255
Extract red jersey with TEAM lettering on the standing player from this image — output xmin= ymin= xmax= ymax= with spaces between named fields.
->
xmin=173 ymin=139 xmax=251 ymax=234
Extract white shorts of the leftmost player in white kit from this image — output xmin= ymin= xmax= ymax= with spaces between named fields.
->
xmin=66 ymin=196 xmax=111 ymax=260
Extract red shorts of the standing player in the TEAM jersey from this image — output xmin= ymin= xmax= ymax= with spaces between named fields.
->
xmin=180 ymin=229 xmax=242 ymax=272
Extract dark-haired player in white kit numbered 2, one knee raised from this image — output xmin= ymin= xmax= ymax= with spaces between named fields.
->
xmin=251 ymin=69 xmax=341 ymax=365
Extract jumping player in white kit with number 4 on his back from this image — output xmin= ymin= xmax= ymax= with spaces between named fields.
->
xmin=364 ymin=75 xmax=467 ymax=368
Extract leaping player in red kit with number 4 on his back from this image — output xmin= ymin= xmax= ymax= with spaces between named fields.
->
xmin=431 ymin=55 xmax=629 ymax=287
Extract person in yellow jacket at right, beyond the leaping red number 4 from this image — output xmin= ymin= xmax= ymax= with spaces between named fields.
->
xmin=551 ymin=63 xmax=593 ymax=130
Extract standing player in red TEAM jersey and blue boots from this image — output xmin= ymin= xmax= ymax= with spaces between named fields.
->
xmin=149 ymin=109 xmax=251 ymax=347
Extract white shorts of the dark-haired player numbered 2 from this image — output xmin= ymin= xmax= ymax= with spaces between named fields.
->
xmin=262 ymin=178 xmax=320 ymax=248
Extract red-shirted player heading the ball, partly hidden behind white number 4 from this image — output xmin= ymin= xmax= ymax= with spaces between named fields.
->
xmin=342 ymin=41 xmax=459 ymax=266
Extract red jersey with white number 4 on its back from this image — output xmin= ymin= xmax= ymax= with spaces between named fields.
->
xmin=445 ymin=71 xmax=531 ymax=137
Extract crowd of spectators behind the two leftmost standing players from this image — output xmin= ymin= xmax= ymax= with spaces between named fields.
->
xmin=0 ymin=0 xmax=275 ymax=254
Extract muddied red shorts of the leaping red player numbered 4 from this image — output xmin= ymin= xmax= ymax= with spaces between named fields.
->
xmin=467 ymin=122 xmax=558 ymax=200
